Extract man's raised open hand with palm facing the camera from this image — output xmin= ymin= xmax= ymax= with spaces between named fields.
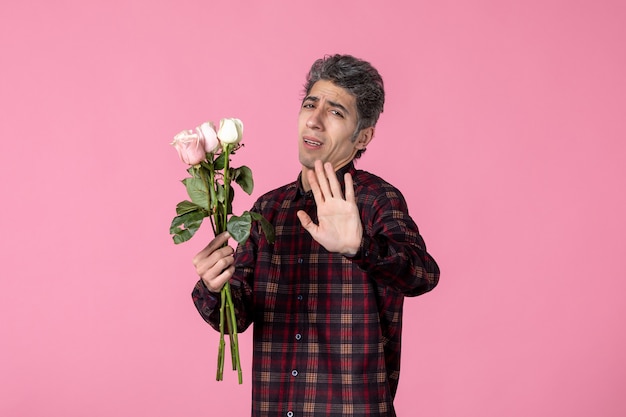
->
xmin=298 ymin=160 xmax=363 ymax=255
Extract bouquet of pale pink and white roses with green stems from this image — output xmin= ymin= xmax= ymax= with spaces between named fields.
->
xmin=170 ymin=118 xmax=274 ymax=384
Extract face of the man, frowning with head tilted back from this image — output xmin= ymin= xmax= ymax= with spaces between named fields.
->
xmin=298 ymin=80 xmax=373 ymax=170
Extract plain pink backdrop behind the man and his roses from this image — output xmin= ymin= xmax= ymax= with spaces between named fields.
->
xmin=0 ymin=0 xmax=626 ymax=417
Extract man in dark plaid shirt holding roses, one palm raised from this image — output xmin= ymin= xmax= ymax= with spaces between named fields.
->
xmin=192 ymin=55 xmax=439 ymax=417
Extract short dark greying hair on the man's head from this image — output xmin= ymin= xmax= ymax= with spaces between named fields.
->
xmin=304 ymin=54 xmax=385 ymax=158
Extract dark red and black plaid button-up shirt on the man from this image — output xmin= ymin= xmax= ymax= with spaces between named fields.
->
xmin=192 ymin=163 xmax=439 ymax=417
